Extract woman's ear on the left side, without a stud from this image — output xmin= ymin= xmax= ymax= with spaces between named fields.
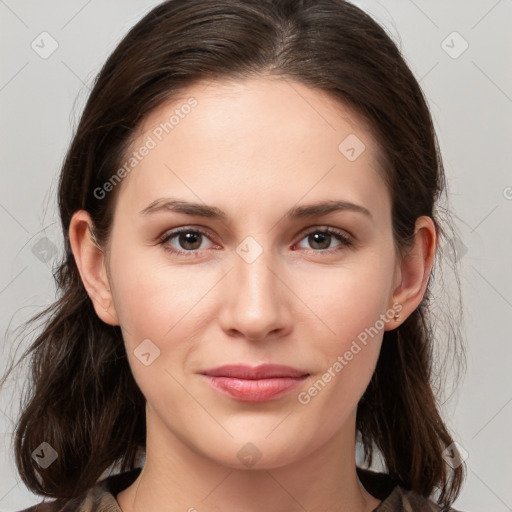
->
xmin=69 ymin=210 xmax=119 ymax=325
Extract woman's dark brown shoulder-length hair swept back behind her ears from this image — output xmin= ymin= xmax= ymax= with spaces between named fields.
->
xmin=3 ymin=0 xmax=464 ymax=504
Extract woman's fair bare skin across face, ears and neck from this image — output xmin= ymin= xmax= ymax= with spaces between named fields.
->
xmin=69 ymin=77 xmax=437 ymax=512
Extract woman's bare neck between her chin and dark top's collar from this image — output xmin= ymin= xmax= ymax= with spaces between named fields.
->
xmin=117 ymin=413 xmax=380 ymax=512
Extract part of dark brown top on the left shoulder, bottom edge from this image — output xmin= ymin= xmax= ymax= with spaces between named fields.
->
xmin=15 ymin=468 xmax=140 ymax=512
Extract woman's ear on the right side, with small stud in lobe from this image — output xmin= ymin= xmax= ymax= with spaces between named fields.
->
xmin=386 ymin=216 xmax=439 ymax=330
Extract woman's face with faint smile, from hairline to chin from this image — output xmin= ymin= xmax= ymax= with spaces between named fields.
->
xmin=103 ymin=79 xmax=399 ymax=468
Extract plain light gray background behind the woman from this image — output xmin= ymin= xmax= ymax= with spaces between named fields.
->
xmin=0 ymin=0 xmax=512 ymax=512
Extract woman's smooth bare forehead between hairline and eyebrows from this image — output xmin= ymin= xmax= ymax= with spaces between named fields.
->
xmin=114 ymin=78 xmax=389 ymax=222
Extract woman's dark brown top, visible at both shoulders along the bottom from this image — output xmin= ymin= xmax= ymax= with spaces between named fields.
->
xmin=16 ymin=467 xmax=457 ymax=512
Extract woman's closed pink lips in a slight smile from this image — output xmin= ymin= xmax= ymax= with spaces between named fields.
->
xmin=200 ymin=364 xmax=309 ymax=402
